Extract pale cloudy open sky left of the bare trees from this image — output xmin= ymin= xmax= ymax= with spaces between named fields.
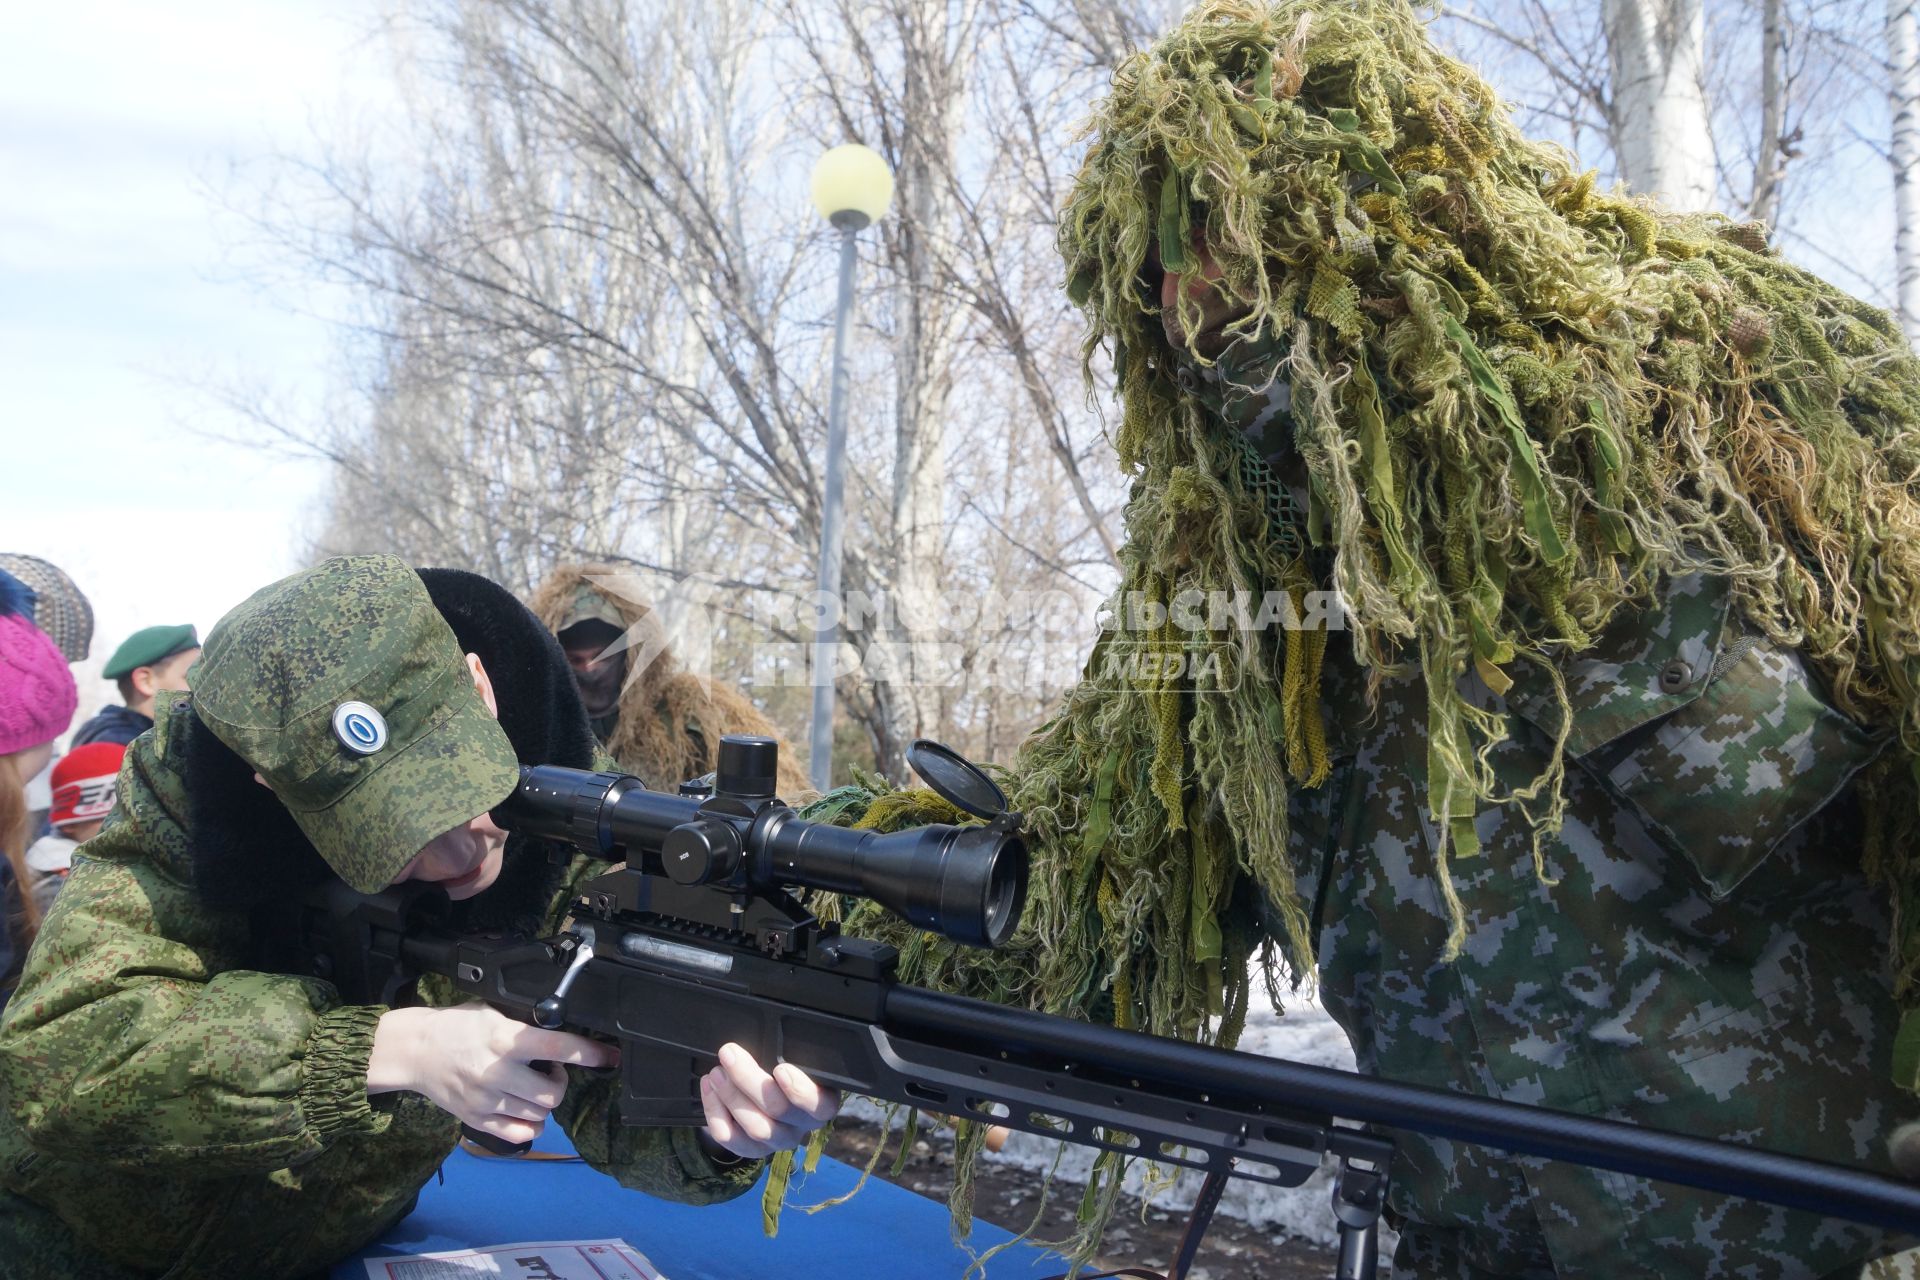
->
xmin=0 ymin=0 xmax=390 ymax=729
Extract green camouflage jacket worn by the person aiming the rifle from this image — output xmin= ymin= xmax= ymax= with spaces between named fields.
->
xmin=0 ymin=704 xmax=760 ymax=1280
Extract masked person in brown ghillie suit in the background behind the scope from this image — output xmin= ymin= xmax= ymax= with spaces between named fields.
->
xmin=528 ymin=564 xmax=812 ymax=798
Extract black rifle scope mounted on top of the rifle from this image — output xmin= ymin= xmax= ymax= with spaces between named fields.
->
xmin=493 ymin=735 xmax=1027 ymax=946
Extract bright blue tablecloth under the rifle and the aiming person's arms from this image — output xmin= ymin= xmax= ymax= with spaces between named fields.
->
xmin=332 ymin=1125 xmax=1066 ymax=1280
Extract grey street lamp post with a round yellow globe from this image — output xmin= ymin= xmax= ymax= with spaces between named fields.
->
xmin=808 ymin=142 xmax=893 ymax=791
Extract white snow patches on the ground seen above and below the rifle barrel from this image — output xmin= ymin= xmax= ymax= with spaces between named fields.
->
xmin=847 ymin=971 xmax=1390 ymax=1249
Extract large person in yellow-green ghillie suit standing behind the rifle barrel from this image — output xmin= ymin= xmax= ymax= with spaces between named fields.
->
xmin=837 ymin=0 xmax=1920 ymax=1278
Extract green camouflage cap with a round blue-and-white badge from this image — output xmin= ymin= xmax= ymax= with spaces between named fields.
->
xmin=188 ymin=557 xmax=520 ymax=892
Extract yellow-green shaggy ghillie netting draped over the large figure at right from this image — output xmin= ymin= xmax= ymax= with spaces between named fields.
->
xmin=771 ymin=0 xmax=1920 ymax=1258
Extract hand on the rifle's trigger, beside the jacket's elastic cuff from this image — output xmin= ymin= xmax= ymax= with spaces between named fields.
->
xmin=367 ymin=1004 xmax=614 ymax=1142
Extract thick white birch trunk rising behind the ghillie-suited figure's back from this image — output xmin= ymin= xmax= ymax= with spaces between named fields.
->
xmin=1605 ymin=0 xmax=1715 ymax=211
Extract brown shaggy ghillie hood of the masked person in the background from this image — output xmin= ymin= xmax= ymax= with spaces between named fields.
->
xmin=528 ymin=564 xmax=812 ymax=796
